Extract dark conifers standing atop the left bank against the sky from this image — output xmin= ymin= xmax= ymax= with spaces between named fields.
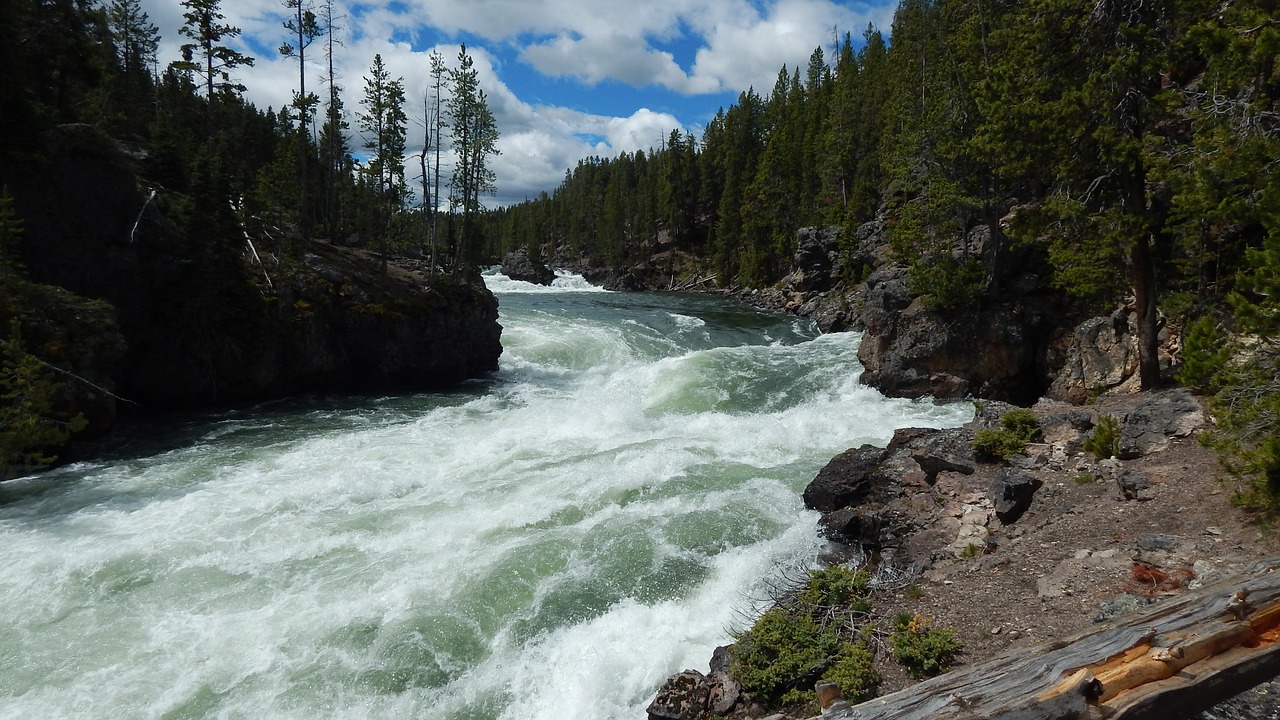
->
xmin=0 ymin=0 xmax=498 ymax=270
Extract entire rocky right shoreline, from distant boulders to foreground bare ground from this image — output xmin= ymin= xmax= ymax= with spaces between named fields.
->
xmin=514 ymin=223 xmax=1280 ymax=720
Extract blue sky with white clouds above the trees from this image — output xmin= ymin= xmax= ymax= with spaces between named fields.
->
xmin=142 ymin=0 xmax=896 ymax=208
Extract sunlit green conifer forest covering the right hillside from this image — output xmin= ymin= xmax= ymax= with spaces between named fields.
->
xmin=492 ymin=0 xmax=1280 ymax=504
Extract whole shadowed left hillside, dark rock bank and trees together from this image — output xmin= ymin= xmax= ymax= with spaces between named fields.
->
xmin=0 ymin=0 xmax=500 ymax=479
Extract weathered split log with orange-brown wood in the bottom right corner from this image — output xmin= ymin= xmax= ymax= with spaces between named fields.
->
xmin=822 ymin=559 xmax=1280 ymax=720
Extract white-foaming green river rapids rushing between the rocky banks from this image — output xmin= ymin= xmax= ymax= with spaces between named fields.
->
xmin=0 ymin=274 xmax=972 ymax=720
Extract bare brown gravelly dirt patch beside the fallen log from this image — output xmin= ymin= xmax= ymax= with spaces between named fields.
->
xmin=860 ymin=396 xmax=1280 ymax=693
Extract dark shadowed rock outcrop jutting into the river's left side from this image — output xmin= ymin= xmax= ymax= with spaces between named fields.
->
xmin=2 ymin=120 xmax=502 ymax=411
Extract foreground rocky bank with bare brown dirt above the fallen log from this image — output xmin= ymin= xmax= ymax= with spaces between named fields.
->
xmin=649 ymin=389 xmax=1280 ymax=720
